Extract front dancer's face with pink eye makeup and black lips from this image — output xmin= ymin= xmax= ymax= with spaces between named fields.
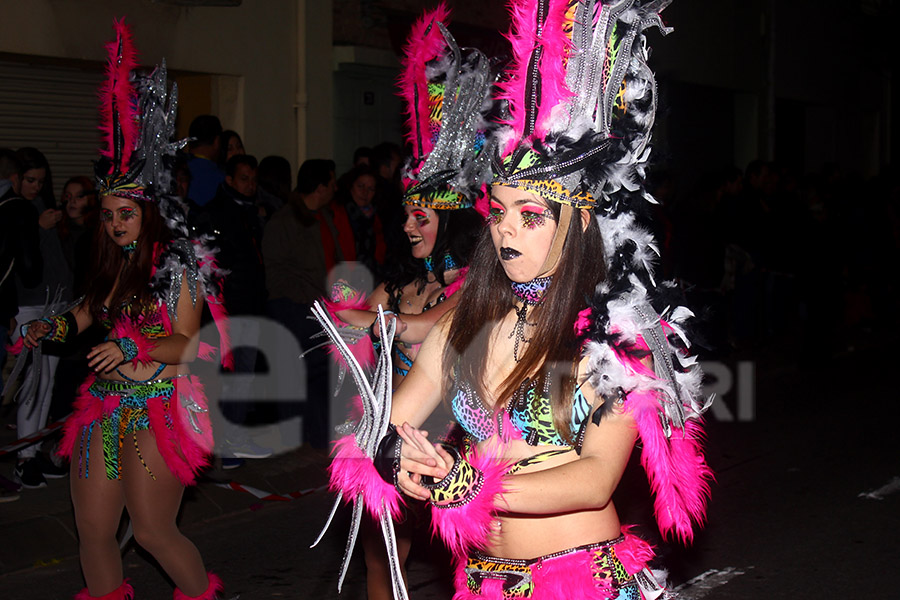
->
xmin=488 ymin=185 xmax=556 ymax=283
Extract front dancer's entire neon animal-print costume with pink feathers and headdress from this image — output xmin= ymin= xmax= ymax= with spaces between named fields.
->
xmin=316 ymin=0 xmax=711 ymax=600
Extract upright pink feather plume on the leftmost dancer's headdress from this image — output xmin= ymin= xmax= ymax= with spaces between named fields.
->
xmin=99 ymin=19 xmax=138 ymax=173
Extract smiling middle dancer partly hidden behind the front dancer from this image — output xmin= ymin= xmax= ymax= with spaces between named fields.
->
xmin=326 ymin=4 xmax=491 ymax=600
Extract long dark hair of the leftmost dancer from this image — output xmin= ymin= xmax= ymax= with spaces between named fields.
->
xmin=84 ymin=200 xmax=172 ymax=321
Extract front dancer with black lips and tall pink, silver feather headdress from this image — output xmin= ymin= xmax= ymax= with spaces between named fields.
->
xmin=320 ymin=0 xmax=712 ymax=600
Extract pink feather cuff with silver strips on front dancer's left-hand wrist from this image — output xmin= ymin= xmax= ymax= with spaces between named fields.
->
xmin=328 ymin=434 xmax=404 ymax=520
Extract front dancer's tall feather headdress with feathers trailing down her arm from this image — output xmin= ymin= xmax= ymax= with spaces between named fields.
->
xmin=493 ymin=0 xmax=712 ymax=541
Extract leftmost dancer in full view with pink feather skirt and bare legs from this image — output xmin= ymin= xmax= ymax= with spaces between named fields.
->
xmin=23 ymin=22 xmax=224 ymax=600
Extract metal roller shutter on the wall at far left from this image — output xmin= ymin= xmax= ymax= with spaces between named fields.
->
xmin=0 ymin=58 xmax=103 ymax=202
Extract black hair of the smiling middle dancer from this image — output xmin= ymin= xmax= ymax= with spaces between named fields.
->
xmin=384 ymin=208 xmax=485 ymax=297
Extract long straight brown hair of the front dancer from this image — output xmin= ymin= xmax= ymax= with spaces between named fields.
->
xmin=443 ymin=202 xmax=606 ymax=442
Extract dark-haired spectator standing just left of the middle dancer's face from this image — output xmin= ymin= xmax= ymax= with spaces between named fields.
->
xmin=338 ymin=165 xmax=387 ymax=281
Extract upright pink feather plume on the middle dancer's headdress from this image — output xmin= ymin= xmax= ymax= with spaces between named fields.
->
xmin=398 ymin=2 xmax=450 ymax=158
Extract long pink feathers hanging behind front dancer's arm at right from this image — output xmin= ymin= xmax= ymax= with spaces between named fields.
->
xmin=618 ymin=336 xmax=713 ymax=543
